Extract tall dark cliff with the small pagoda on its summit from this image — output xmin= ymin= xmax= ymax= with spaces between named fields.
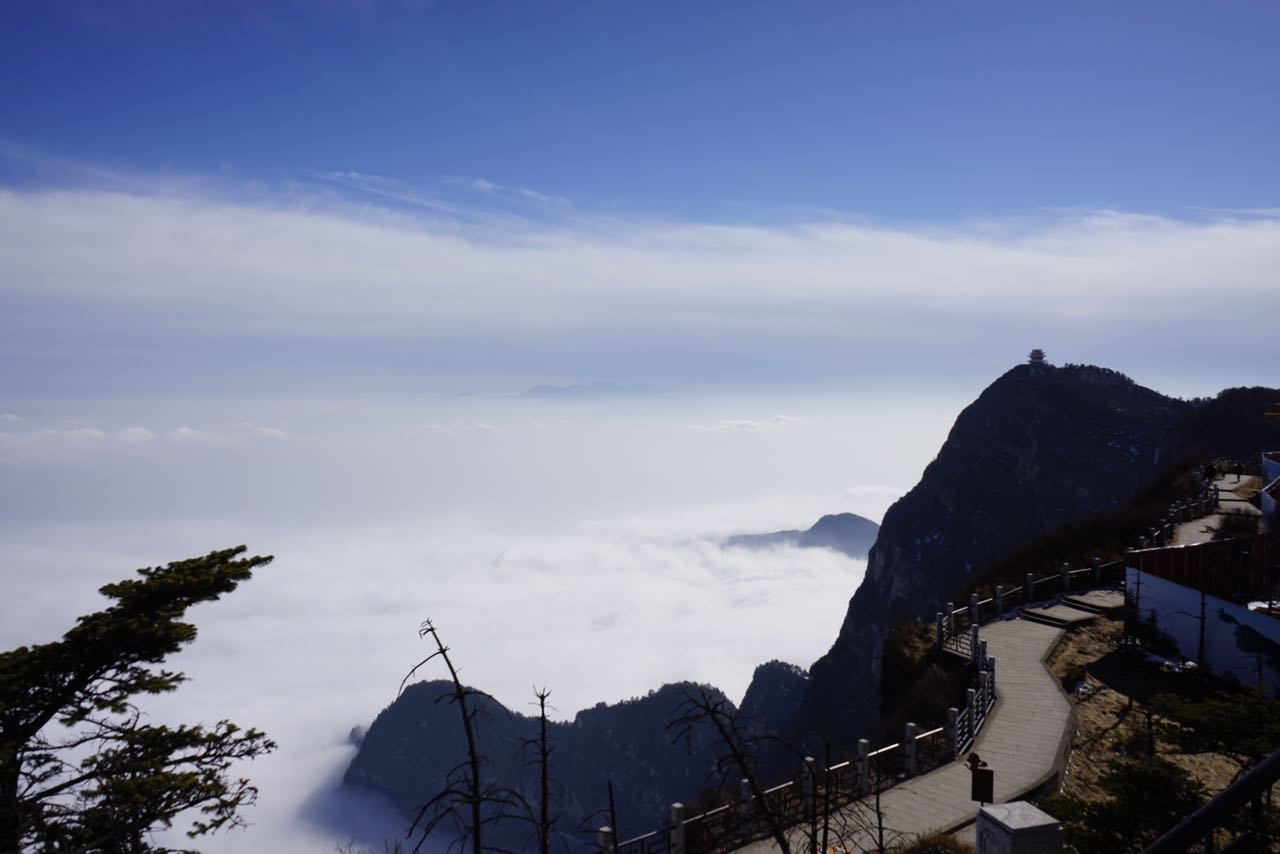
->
xmin=799 ymin=365 xmax=1192 ymax=745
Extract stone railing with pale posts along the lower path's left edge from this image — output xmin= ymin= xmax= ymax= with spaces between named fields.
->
xmin=611 ymin=655 xmax=996 ymax=854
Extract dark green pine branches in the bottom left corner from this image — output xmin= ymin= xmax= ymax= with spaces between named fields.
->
xmin=0 ymin=545 xmax=275 ymax=854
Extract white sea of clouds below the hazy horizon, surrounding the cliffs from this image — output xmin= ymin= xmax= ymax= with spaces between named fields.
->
xmin=0 ymin=397 xmax=954 ymax=851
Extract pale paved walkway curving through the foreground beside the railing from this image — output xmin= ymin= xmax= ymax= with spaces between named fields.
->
xmin=740 ymin=594 xmax=1123 ymax=854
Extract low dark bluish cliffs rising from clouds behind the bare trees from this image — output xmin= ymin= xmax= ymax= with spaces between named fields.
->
xmin=343 ymin=681 xmax=722 ymax=850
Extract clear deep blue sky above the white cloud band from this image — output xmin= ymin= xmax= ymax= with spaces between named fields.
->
xmin=0 ymin=1 xmax=1280 ymax=219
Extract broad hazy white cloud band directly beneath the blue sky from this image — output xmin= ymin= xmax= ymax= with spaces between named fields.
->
xmin=0 ymin=184 xmax=1280 ymax=391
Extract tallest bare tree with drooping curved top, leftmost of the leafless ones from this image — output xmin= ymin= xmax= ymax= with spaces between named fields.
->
xmin=397 ymin=620 xmax=525 ymax=854
